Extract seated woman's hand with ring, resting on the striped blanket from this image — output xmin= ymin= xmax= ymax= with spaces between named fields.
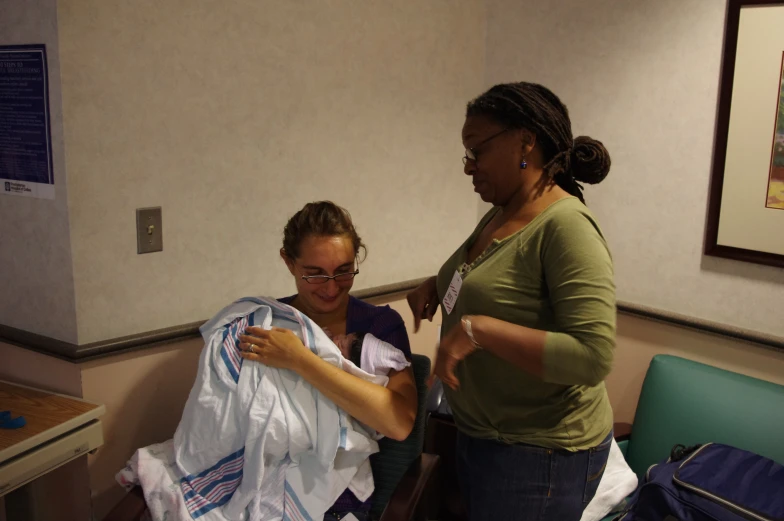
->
xmin=240 ymin=327 xmax=312 ymax=372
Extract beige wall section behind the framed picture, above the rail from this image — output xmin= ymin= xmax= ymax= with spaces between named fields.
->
xmin=485 ymin=0 xmax=784 ymax=337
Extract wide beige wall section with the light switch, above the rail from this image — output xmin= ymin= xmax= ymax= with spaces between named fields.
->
xmin=58 ymin=0 xmax=484 ymax=343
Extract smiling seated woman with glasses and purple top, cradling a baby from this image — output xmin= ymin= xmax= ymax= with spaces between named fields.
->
xmin=240 ymin=201 xmax=417 ymax=520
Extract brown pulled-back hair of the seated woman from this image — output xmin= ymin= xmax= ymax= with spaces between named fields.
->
xmin=283 ymin=201 xmax=367 ymax=259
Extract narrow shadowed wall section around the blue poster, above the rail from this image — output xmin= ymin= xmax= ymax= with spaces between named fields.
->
xmin=0 ymin=0 xmax=77 ymax=342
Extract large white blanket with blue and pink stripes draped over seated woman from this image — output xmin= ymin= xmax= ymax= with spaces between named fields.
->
xmin=118 ymin=298 xmax=396 ymax=521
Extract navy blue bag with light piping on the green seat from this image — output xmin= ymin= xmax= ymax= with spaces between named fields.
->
xmin=614 ymin=441 xmax=784 ymax=521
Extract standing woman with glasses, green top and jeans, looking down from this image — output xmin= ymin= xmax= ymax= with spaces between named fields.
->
xmin=408 ymin=83 xmax=615 ymax=521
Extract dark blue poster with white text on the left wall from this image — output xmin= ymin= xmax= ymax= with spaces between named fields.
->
xmin=0 ymin=45 xmax=54 ymax=199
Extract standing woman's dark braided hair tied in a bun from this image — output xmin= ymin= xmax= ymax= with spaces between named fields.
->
xmin=466 ymin=82 xmax=610 ymax=203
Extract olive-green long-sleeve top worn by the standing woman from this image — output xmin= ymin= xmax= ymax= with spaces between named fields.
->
xmin=438 ymin=197 xmax=616 ymax=451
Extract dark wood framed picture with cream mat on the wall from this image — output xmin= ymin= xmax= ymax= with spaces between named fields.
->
xmin=705 ymin=0 xmax=784 ymax=268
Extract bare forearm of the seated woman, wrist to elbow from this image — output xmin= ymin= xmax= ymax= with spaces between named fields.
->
xmin=296 ymin=352 xmax=417 ymax=440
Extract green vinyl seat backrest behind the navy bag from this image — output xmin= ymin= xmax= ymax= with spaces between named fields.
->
xmin=626 ymin=355 xmax=784 ymax=476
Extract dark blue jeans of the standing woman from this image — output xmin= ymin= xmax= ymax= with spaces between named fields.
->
xmin=457 ymin=433 xmax=612 ymax=521
